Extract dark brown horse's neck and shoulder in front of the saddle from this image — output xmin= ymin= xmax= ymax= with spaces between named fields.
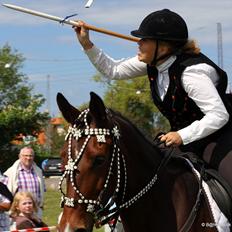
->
xmin=115 ymin=119 xmax=208 ymax=232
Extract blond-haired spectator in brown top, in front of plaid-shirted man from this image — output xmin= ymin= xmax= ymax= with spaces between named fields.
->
xmin=11 ymin=192 xmax=47 ymax=231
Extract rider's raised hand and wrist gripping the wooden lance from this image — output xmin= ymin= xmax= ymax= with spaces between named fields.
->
xmin=73 ymin=21 xmax=93 ymax=50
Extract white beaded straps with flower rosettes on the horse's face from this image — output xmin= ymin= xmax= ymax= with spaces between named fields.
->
xmin=59 ymin=109 xmax=125 ymax=213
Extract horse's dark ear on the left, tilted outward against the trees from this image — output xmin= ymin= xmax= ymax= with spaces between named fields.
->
xmin=56 ymin=93 xmax=80 ymax=124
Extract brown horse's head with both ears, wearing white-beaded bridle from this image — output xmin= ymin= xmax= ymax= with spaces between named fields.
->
xmin=57 ymin=93 xmax=120 ymax=232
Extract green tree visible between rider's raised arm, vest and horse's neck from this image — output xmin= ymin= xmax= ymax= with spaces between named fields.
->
xmin=94 ymin=74 xmax=169 ymax=137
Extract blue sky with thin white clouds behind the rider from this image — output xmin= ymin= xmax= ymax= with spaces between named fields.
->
xmin=0 ymin=0 xmax=232 ymax=116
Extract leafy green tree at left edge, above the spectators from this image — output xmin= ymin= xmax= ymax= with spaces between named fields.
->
xmin=0 ymin=45 xmax=48 ymax=169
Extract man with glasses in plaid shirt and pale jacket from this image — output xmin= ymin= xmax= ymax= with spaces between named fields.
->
xmin=4 ymin=147 xmax=45 ymax=218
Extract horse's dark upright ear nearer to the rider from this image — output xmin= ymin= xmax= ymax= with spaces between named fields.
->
xmin=89 ymin=92 xmax=106 ymax=122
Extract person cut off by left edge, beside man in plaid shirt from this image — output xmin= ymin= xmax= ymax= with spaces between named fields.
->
xmin=0 ymin=173 xmax=13 ymax=231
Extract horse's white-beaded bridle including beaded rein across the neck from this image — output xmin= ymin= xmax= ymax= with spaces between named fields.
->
xmin=59 ymin=109 xmax=160 ymax=224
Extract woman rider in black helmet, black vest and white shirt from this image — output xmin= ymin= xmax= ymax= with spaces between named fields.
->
xmin=74 ymin=9 xmax=232 ymax=186
